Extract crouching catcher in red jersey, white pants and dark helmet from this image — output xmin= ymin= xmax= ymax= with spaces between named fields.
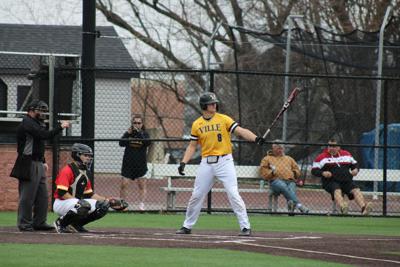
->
xmin=53 ymin=143 xmax=128 ymax=233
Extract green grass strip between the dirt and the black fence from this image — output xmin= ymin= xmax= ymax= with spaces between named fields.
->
xmin=0 ymin=212 xmax=400 ymax=236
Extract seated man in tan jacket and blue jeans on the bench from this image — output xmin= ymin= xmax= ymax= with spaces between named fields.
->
xmin=260 ymin=140 xmax=309 ymax=213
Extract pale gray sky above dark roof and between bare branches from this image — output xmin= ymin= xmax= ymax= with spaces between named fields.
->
xmin=0 ymin=0 xmax=225 ymax=66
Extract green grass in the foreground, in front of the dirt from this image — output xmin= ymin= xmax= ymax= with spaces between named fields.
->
xmin=0 ymin=244 xmax=347 ymax=267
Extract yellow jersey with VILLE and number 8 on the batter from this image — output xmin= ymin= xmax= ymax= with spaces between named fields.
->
xmin=190 ymin=113 xmax=238 ymax=157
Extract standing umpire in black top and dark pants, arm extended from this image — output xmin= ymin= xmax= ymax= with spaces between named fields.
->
xmin=11 ymin=100 xmax=70 ymax=232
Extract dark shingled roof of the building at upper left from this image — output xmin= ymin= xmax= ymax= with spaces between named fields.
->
xmin=0 ymin=24 xmax=137 ymax=69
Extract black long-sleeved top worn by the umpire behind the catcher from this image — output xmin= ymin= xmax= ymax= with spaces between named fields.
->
xmin=17 ymin=116 xmax=62 ymax=162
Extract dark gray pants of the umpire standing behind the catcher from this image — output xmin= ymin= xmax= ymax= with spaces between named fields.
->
xmin=17 ymin=161 xmax=48 ymax=229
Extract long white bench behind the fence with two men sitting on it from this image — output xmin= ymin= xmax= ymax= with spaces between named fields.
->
xmin=148 ymin=163 xmax=400 ymax=212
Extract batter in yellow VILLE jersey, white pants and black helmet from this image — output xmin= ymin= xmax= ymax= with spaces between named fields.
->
xmin=176 ymin=92 xmax=264 ymax=236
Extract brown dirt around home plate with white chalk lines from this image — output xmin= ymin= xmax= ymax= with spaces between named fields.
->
xmin=0 ymin=227 xmax=400 ymax=266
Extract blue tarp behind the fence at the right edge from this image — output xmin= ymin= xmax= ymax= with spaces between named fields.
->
xmin=360 ymin=123 xmax=400 ymax=192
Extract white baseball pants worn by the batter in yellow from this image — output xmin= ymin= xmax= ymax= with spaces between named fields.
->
xmin=183 ymin=154 xmax=250 ymax=229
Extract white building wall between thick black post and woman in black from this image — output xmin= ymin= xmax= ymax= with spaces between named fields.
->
xmin=94 ymin=79 xmax=132 ymax=173
